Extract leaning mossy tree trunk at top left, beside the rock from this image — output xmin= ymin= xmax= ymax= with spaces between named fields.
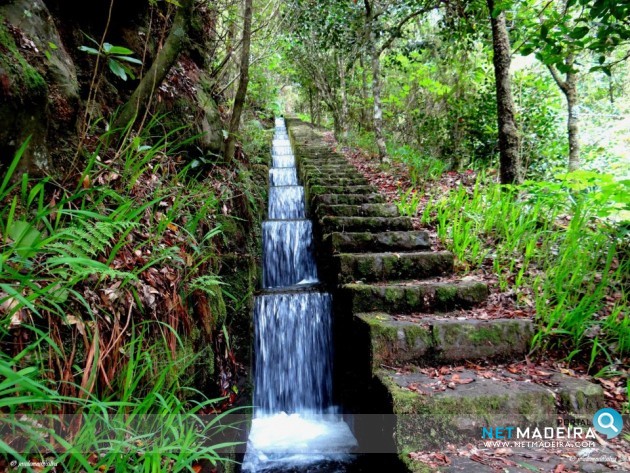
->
xmin=114 ymin=0 xmax=195 ymax=128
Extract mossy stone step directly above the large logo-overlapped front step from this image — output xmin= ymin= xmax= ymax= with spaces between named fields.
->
xmin=355 ymin=312 xmax=534 ymax=370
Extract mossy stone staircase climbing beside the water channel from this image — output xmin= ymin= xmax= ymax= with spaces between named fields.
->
xmin=287 ymin=120 xmax=610 ymax=472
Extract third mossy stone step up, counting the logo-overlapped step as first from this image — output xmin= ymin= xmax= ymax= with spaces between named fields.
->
xmin=341 ymin=281 xmax=488 ymax=314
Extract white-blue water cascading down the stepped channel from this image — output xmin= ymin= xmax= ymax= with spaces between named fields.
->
xmin=243 ymin=119 xmax=357 ymax=472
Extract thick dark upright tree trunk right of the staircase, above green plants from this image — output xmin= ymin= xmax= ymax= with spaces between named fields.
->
xmin=487 ymin=0 xmax=521 ymax=184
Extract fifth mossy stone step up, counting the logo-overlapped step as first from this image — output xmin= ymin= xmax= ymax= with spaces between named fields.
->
xmin=323 ymin=230 xmax=431 ymax=253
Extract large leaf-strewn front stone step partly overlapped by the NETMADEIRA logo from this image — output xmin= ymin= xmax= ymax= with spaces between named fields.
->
xmin=376 ymin=366 xmax=604 ymax=452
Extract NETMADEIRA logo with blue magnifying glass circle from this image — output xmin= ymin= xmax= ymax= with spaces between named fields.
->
xmin=481 ymin=407 xmax=623 ymax=447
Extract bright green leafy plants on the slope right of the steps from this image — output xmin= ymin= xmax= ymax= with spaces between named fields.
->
xmin=423 ymin=172 xmax=630 ymax=364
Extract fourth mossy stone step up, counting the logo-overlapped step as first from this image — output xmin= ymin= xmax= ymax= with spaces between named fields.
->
xmin=334 ymin=251 xmax=453 ymax=283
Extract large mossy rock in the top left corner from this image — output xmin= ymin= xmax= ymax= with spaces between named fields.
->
xmin=0 ymin=0 xmax=79 ymax=174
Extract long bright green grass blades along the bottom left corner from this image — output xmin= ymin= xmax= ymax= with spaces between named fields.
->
xmin=0 ymin=322 xmax=242 ymax=472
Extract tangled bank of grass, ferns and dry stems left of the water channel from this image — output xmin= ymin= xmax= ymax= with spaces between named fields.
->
xmin=0 ymin=118 xmax=247 ymax=471
